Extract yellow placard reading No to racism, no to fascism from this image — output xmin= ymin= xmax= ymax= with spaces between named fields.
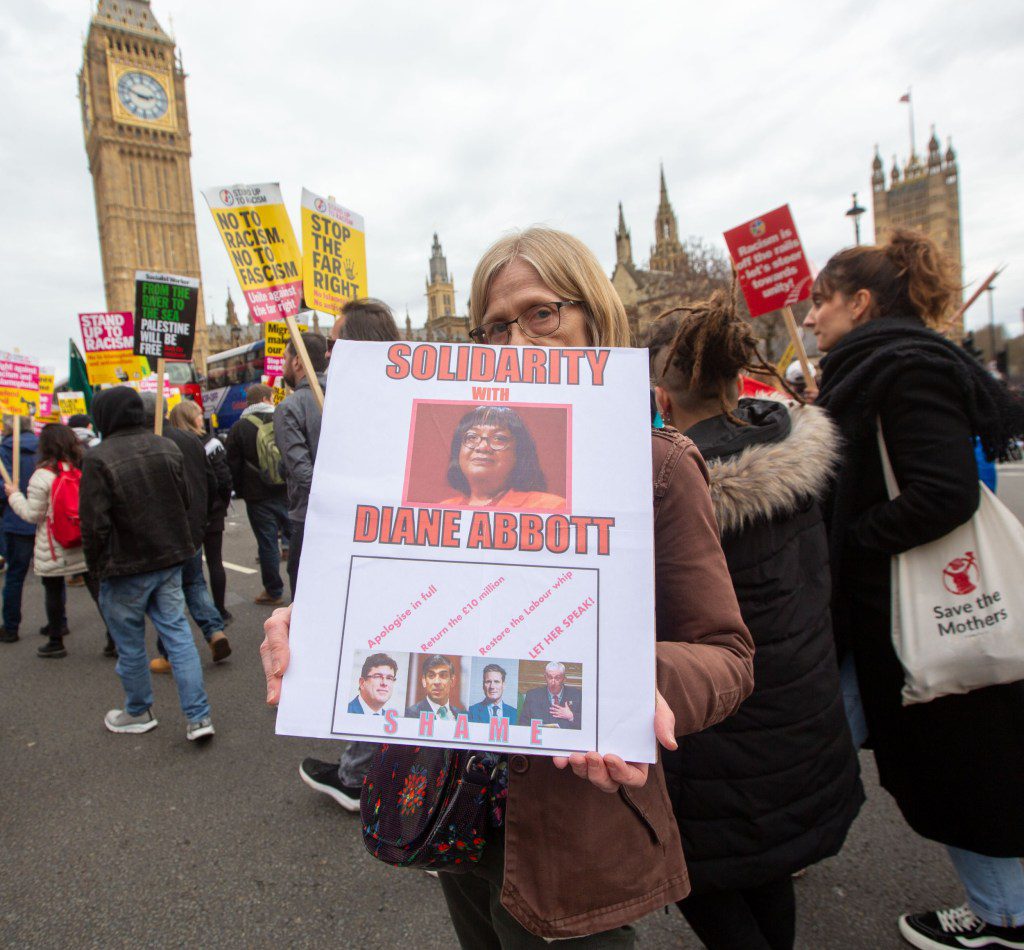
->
xmin=203 ymin=182 xmax=302 ymax=323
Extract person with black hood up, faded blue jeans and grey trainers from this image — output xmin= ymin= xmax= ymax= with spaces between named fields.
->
xmin=79 ymin=386 xmax=213 ymax=740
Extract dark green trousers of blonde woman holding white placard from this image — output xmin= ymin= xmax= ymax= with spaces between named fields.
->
xmin=437 ymin=829 xmax=636 ymax=950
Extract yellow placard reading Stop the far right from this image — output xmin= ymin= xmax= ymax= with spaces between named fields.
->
xmin=302 ymin=188 xmax=368 ymax=316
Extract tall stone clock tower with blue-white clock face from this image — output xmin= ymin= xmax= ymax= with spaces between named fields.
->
xmin=78 ymin=0 xmax=208 ymax=373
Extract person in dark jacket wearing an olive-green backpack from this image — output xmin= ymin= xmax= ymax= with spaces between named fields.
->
xmin=227 ymin=383 xmax=292 ymax=607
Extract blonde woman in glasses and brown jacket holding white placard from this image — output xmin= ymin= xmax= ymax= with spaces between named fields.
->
xmin=260 ymin=227 xmax=753 ymax=948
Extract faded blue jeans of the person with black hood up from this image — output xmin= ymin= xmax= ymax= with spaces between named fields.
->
xmin=99 ymin=566 xmax=210 ymax=723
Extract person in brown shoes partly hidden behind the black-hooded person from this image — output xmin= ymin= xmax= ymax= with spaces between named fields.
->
xmin=141 ymin=392 xmax=231 ymax=673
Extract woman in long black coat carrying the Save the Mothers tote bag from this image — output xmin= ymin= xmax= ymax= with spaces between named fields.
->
xmin=804 ymin=230 xmax=1024 ymax=948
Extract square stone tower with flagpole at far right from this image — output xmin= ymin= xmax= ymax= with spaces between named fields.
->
xmin=871 ymin=126 xmax=963 ymax=339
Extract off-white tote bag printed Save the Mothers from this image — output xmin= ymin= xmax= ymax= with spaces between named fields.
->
xmin=879 ymin=424 xmax=1024 ymax=705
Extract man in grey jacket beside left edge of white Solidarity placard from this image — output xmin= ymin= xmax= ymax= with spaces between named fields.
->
xmin=273 ymin=333 xmax=327 ymax=600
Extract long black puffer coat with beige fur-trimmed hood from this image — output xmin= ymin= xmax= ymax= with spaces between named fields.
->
xmin=664 ymin=399 xmax=864 ymax=893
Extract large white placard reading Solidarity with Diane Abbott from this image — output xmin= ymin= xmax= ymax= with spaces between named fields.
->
xmin=276 ymin=342 xmax=655 ymax=762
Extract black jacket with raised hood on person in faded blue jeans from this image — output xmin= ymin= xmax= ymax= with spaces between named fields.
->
xmin=79 ymin=386 xmax=194 ymax=578
